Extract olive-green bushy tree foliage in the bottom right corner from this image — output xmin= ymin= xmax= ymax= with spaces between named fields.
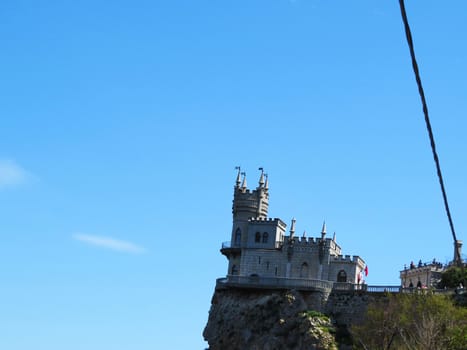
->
xmin=351 ymin=293 xmax=467 ymax=350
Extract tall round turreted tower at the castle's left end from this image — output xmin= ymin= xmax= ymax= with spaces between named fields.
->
xmin=231 ymin=167 xmax=269 ymax=246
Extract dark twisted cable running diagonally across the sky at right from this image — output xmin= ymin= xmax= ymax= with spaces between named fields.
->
xmin=399 ymin=0 xmax=461 ymax=263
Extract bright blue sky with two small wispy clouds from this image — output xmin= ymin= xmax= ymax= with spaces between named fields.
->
xmin=0 ymin=0 xmax=467 ymax=350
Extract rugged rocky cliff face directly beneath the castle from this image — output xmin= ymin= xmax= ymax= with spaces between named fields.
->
xmin=203 ymin=289 xmax=337 ymax=350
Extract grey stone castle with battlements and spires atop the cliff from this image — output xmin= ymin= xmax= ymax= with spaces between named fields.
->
xmin=221 ymin=167 xmax=366 ymax=288
